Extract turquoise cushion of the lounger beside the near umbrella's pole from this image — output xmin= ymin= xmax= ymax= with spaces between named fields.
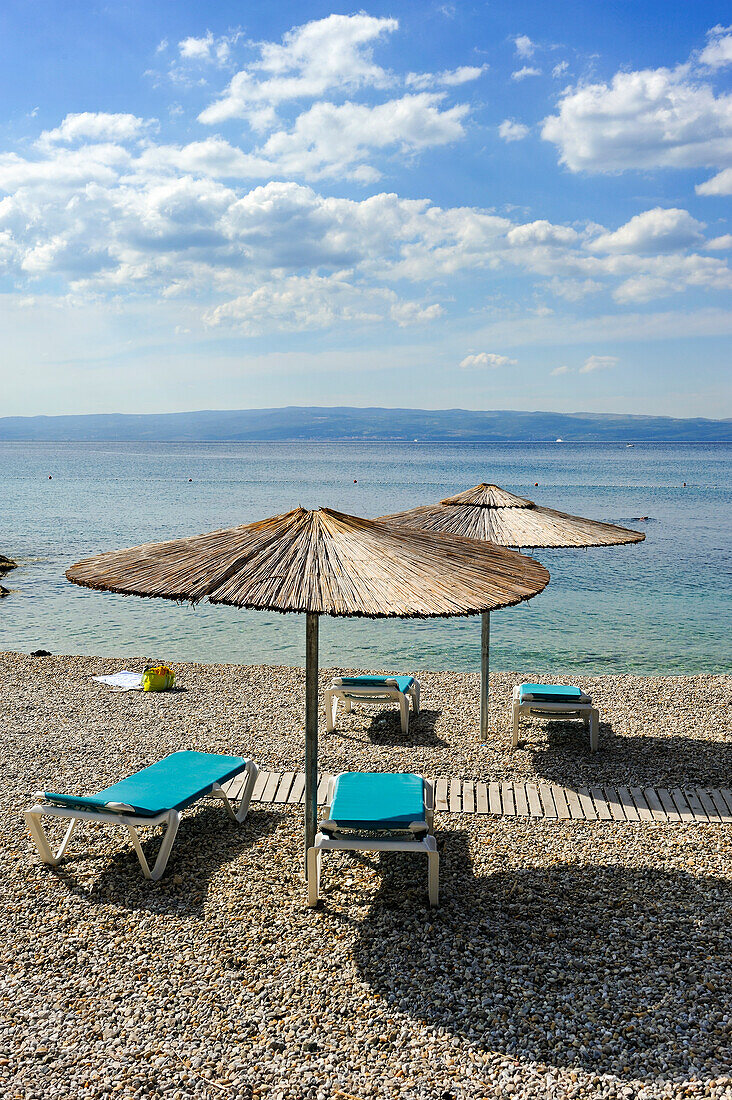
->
xmin=330 ymin=771 xmax=425 ymax=829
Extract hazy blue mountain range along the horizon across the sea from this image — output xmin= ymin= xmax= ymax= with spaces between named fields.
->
xmin=0 ymin=406 xmax=732 ymax=443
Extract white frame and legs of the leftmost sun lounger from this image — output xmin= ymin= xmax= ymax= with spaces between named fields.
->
xmin=24 ymin=760 xmax=259 ymax=882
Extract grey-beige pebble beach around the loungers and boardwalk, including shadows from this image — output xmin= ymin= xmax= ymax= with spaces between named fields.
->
xmin=0 ymin=653 xmax=732 ymax=1100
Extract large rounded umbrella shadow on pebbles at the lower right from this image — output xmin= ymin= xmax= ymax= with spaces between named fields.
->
xmin=354 ymin=833 xmax=732 ymax=1080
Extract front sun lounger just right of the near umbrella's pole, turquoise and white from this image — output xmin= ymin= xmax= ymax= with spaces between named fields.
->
xmin=307 ymin=771 xmax=439 ymax=906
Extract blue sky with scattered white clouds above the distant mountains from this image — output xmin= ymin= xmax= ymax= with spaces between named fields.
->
xmin=0 ymin=0 xmax=732 ymax=417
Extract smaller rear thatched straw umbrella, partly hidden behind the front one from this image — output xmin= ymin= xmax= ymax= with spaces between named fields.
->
xmin=379 ymin=484 xmax=645 ymax=737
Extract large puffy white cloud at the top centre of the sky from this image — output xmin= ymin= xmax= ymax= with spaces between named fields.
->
xmin=185 ymin=13 xmax=473 ymax=184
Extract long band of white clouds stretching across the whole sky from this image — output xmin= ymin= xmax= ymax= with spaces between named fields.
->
xmin=0 ymin=138 xmax=730 ymax=312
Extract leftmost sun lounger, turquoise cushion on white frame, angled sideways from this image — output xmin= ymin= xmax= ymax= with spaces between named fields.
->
xmin=25 ymin=751 xmax=258 ymax=880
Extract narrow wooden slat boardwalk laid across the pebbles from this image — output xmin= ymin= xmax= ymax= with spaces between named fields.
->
xmin=225 ymin=771 xmax=732 ymax=824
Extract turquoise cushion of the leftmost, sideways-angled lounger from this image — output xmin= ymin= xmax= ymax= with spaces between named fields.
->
xmin=45 ymin=749 xmax=247 ymax=817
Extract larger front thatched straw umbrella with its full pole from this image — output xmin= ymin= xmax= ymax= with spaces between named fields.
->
xmin=66 ymin=508 xmax=549 ymax=871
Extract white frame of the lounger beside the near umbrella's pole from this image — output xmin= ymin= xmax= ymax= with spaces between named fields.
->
xmin=307 ymin=776 xmax=439 ymax=909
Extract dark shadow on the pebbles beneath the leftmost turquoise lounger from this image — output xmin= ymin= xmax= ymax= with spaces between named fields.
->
xmin=52 ymin=806 xmax=281 ymax=916
